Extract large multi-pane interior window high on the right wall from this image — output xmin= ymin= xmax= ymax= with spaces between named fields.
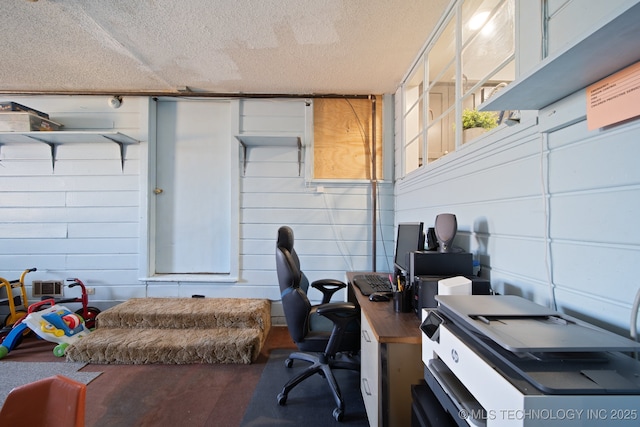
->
xmin=402 ymin=0 xmax=515 ymax=175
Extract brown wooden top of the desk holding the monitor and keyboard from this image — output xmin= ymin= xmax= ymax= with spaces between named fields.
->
xmin=347 ymin=272 xmax=422 ymax=344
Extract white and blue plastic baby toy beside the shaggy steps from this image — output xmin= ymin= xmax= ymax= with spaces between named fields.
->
xmin=0 ymin=299 xmax=90 ymax=359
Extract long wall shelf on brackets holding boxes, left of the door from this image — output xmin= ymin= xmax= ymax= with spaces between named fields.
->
xmin=0 ymin=131 xmax=140 ymax=170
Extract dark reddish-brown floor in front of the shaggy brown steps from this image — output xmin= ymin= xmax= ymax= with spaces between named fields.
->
xmin=7 ymin=326 xmax=295 ymax=427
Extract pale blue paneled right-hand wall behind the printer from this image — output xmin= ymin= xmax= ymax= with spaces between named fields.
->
xmin=395 ymin=0 xmax=640 ymax=336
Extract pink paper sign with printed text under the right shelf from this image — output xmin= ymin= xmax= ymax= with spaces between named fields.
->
xmin=587 ymin=62 xmax=640 ymax=130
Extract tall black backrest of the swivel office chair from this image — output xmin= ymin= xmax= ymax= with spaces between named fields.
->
xmin=276 ymin=226 xmax=311 ymax=343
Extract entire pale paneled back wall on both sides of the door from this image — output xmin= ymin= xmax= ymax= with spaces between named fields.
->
xmin=0 ymin=96 xmax=394 ymax=317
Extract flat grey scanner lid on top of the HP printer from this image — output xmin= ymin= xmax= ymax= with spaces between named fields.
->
xmin=435 ymin=295 xmax=640 ymax=353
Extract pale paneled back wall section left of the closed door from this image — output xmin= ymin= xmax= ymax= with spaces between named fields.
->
xmin=0 ymin=96 xmax=148 ymax=306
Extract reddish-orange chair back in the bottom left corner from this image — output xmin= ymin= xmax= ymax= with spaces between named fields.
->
xmin=0 ymin=375 xmax=87 ymax=427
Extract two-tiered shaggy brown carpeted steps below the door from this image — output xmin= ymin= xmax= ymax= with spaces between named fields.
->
xmin=65 ymin=298 xmax=271 ymax=364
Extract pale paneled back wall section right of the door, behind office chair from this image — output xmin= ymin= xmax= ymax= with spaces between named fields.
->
xmin=240 ymin=100 xmax=394 ymax=312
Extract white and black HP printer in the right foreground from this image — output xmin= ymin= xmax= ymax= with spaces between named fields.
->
xmin=421 ymin=295 xmax=640 ymax=427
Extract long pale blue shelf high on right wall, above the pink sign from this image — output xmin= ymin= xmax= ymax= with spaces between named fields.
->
xmin=478 ymin=3 xmax=640 ymax=111
